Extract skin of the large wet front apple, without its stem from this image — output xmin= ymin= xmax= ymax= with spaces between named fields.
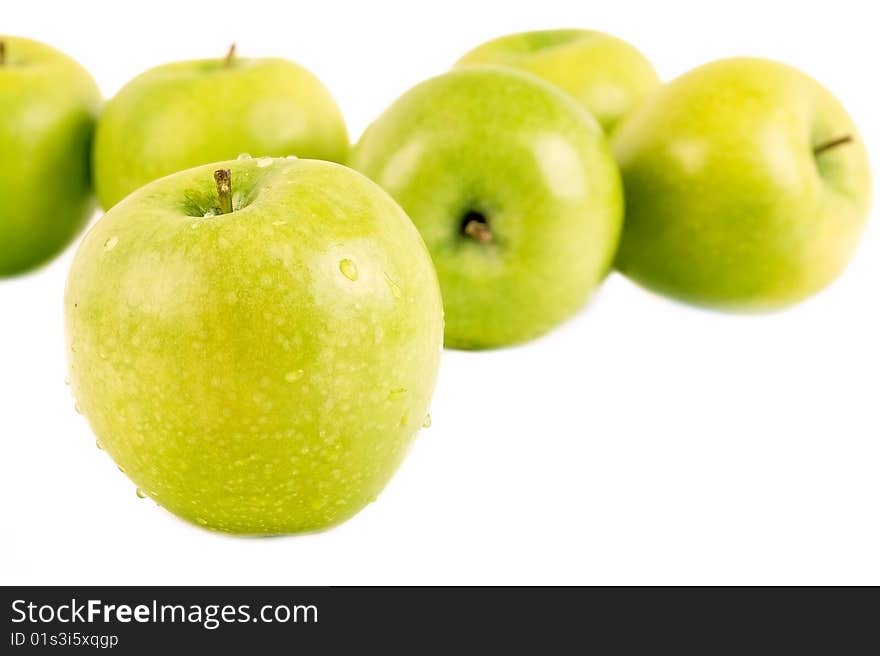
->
xmin=64 ymin=158 xmax=443 ymax=535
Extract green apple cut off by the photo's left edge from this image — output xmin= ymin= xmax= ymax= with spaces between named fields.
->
xmin=0 ymin=35 xmax=101 ymax=276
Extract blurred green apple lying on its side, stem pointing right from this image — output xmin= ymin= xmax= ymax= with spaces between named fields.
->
xmin=614 ymin=58 xmax=871 ymax=310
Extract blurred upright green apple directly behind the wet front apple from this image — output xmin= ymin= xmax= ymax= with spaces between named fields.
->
xmin=94 ymin=46 xmax=349 ymax=209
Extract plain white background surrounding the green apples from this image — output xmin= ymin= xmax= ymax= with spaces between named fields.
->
xmin=0 ymin=0 xmax=880 ymax=584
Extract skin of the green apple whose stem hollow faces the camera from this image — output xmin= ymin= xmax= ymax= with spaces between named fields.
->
xmin=351 ymin=67 xmax=623 ymax=349
